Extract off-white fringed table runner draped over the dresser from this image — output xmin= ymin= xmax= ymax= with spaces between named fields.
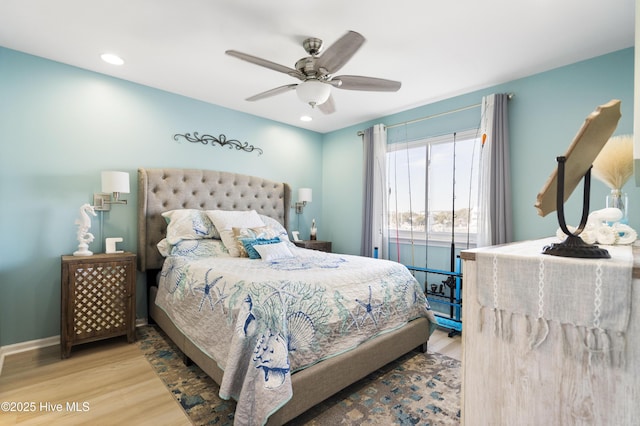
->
xmin=476 ymin=237 xmax=633 ymax=366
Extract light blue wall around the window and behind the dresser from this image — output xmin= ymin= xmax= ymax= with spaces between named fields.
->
xmin=322 ymin=48 xmax=640 ymax=269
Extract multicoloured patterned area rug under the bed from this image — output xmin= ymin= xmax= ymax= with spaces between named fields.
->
xmin=138 ymin=326 xmax=461 ymax=425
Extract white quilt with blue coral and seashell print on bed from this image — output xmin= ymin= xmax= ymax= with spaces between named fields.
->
xmin=156 ymin=244 xmax=436 ymax=425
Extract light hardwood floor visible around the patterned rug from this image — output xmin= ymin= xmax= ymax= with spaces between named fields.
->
xmin=0 ymin=330 xmax=462 ymax=426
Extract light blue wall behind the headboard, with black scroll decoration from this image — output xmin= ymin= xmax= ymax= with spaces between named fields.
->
xmin=0 ymin=48 xmax=323 ymax=346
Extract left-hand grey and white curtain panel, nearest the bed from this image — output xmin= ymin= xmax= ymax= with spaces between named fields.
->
xmin=360 ymin=124 xmax=389 ymax=259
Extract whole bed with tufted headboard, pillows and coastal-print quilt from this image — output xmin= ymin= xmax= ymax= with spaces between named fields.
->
xmin=138 ymin=168 xmax=436 ymax=424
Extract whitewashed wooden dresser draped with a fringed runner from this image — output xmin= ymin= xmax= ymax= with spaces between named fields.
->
xmin=461 ymin=239 xmax=640 ymax=425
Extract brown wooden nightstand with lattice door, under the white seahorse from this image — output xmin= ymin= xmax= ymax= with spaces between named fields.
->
xmin=60 ymin=253 xmax=136 ymax=358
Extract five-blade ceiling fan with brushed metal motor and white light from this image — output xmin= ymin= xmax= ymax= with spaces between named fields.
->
xmin=226 ymin=31 xmax=401 ymax=114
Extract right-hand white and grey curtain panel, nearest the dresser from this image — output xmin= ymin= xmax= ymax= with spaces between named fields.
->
xmin=477 ymin=94 xmax=513 ymax=247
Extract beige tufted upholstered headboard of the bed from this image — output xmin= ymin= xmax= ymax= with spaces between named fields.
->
xmin=138 ymin=168 xmax=291 ymax=271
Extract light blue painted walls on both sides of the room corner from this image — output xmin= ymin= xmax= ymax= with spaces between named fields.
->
xmin=0 ymin=48 xmax=640 ymax=346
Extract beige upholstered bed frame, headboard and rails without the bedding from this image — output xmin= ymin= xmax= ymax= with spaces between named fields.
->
xmin=138 ymin=168 xmax=430 ymax=425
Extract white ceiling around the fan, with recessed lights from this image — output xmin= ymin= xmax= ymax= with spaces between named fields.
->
xmin=0 ymin=0 xmax=635 ymax=133
